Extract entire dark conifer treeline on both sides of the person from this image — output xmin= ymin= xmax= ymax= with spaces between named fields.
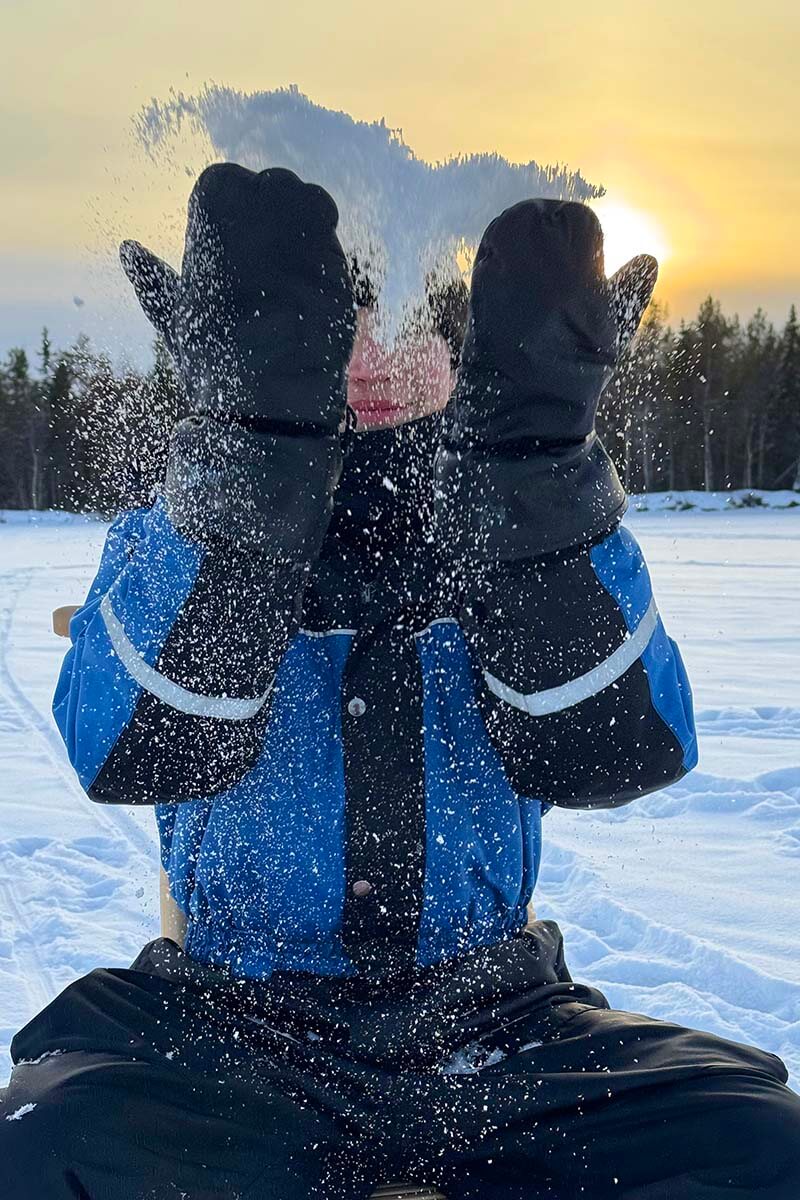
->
xmin=0 ymin=296 xmax=800 ymax=515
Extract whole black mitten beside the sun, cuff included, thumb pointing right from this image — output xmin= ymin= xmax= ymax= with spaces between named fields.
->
xmin=437 ymin=200 xmax=657 ymax=559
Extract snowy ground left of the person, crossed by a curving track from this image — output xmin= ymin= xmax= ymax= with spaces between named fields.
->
xmin=0 ymin=540 xmax=156 ymax=1080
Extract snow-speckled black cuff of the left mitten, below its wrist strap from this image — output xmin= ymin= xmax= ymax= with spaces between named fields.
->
xmin=164 ymin=416 xmax=342 ymax=563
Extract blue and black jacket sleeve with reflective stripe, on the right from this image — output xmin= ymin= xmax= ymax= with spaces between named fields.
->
xmin=462 ymin=527 xmax=697 ymax=808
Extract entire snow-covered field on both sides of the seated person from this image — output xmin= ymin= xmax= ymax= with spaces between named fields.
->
xmin=0 ymin=509 xmax=800 ymax=1087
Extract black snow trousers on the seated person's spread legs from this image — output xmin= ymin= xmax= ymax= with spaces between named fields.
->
xmin=0 ymin=922 xmax=800 ymax=1200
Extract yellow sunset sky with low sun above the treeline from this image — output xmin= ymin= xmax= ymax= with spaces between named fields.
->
xmin=0 ymin=0 xmax=800 ymax=352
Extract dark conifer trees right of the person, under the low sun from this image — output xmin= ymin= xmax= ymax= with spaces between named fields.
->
xmin=597 ymin=296 xmax=800 ymax=492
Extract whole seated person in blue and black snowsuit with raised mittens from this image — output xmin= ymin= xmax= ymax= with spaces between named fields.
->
xmin=0 ymin=164 xmax=800 ymax=1200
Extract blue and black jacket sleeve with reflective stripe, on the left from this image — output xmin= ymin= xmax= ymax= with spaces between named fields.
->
xmin=54 ymin=502 xmax=305 ymax=804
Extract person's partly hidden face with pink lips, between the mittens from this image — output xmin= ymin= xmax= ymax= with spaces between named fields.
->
xmin=348 ymin=308 xmax=453 ymax=430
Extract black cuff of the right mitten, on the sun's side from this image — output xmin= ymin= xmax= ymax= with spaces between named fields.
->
xmin=435 ymin=433 xmax=627 ymax=562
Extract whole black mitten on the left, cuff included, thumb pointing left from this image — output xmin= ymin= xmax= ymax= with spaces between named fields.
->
xmin=120 ymin=163 xmax=355 ymax=560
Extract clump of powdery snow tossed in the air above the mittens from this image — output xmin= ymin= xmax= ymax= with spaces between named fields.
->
xmin=137 ymin=85 xmax=602 ymax=340
